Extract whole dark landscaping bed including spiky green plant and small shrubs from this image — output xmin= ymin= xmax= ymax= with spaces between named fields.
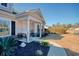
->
xmin=0 ymin=36 xmax=50 ymax=56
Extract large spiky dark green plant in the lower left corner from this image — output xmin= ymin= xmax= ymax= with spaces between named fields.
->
xmin=0 ymin=37 xmax=17 ymax=56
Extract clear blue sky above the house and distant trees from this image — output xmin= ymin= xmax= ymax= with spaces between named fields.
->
xmin=14 ymin=3 xmax=79 ymax=26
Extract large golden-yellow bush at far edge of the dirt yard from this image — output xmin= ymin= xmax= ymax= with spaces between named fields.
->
xmin=49 ymin=25 xmax=70 ymax=34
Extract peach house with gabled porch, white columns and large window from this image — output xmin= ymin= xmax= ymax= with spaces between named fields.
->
xmin=0 ymin=3 xmax=45 ymax=42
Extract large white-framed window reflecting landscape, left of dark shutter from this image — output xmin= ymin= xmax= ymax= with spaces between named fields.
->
xmin=0 ymin=18 xmax=10 ymax=37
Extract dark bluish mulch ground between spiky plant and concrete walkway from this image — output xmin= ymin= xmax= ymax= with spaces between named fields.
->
xmin=14 ymin=41 xmax=50 ymax=56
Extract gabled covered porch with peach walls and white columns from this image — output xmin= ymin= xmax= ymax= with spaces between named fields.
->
xmin=16 ymin=9 xmax=44 ymax=43
